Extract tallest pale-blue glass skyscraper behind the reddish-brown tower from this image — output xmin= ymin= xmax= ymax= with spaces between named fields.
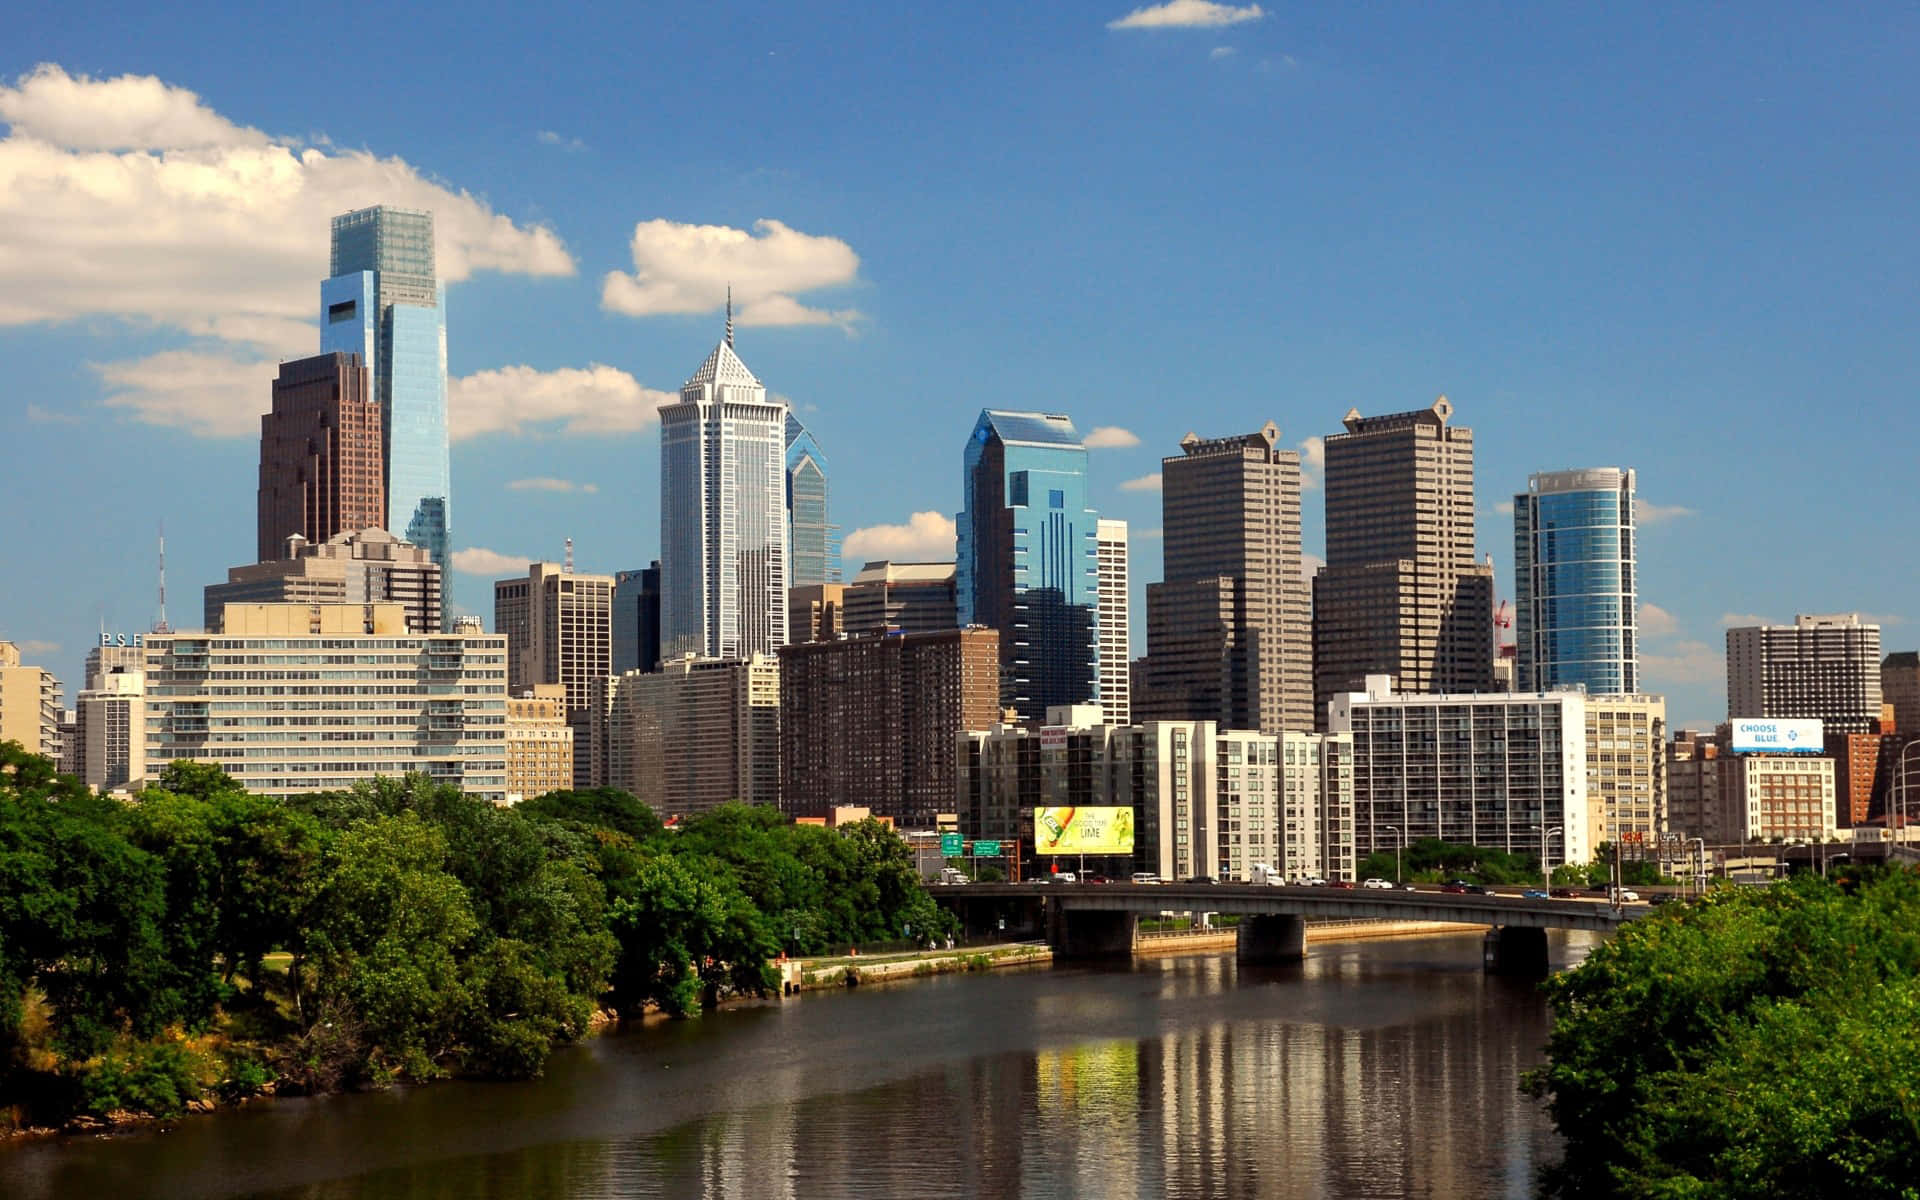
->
xmin=321 ymin=205 xmax=453 ymax=612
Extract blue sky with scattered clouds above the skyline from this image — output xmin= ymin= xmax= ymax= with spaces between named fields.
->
xmin=0 ymin=0 xmax=1920 ymax=722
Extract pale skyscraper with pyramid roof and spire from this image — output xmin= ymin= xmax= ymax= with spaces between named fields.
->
xmin=660 ymin=309 xmax=789 ymax=659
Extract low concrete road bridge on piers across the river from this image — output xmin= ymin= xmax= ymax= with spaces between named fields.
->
xmin=931 ymin=883 xmax=1651 ymax=973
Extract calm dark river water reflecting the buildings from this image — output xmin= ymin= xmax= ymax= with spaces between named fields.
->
xmin=0 ymin=933 xmax=1590 ymax=1200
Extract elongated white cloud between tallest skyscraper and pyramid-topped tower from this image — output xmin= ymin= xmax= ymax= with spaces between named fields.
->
xmin=447 ymin=363 xmax=680 ymax=442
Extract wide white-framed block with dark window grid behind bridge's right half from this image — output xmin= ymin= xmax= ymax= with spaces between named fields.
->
xmin=1329 ymin=676 xmax=1599 ymax=866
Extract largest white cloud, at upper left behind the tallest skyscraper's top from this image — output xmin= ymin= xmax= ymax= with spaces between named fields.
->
xmin=0 ymin=65 xmax=574 ymax=355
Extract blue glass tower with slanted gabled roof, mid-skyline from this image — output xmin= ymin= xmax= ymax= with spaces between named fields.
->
xmin=954 ymin=409 xmax=1100 ymax=720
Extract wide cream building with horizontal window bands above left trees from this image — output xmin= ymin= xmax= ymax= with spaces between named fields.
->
xmin=146 ymin=605 xmax=507 ymax=803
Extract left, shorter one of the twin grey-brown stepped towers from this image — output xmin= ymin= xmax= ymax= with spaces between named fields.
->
xmin=1135 ymin=420 xmax=1313 ymax=733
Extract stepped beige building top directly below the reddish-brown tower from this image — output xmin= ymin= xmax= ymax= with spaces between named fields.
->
xmin=205 ymin=528 xmax=445 ymax=634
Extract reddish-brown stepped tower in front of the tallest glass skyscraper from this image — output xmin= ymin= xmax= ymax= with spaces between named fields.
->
xmin=257 ymin=351 xmax=386 ymax=563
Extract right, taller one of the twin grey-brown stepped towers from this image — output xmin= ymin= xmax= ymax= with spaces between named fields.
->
xmin=1313 ymin=396 xmax=1494 ymax=722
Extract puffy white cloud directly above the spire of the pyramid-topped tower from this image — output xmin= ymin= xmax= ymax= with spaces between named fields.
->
xmin=601 ymin=221 xmax=860 ymax=328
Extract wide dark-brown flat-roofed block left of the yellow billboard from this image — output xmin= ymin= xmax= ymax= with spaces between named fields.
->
xmin=780 ymin=628 xmax=1000 ymax=829
